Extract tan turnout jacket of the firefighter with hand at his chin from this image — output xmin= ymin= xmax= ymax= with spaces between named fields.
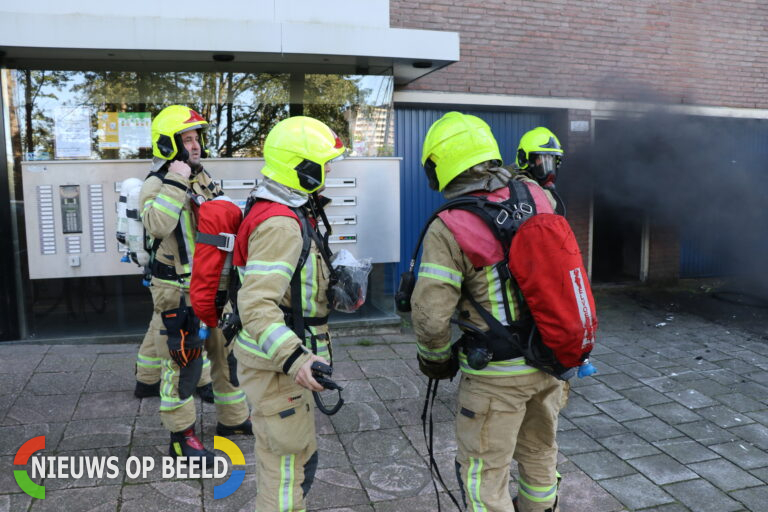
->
xmin=139 ymin=167 xmax=222 ymax=288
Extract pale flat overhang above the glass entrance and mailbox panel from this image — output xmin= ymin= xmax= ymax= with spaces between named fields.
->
xmin=0 ymin=11 xmax=459 ymax=84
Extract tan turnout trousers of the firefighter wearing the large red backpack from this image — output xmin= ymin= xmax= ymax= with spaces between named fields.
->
xmin=456 ymin=371 xmax=563 ymax=512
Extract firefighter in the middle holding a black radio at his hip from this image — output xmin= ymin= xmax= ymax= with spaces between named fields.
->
xmin=233 ymin=116 xmax=344 ymax=511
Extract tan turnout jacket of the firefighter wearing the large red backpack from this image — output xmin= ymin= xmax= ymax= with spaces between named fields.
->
xmin=411 ymin=176 xmax=555 ymax=376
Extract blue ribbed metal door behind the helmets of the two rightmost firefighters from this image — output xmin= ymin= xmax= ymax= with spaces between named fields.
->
xmin=395 ymin=107 xmax=550 ymax=273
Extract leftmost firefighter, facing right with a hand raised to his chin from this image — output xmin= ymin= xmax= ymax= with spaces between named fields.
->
xmin=139 ymin=105 xmax=252 ymax=466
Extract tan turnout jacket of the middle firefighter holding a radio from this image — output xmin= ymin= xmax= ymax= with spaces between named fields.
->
xmin=234 ymin=215 xmax=329 ymax=377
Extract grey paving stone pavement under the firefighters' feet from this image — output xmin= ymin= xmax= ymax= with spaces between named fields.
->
xmin=0 ymin=293 xmax=768 ymax=512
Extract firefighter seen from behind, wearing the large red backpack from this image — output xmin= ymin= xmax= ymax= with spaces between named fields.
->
xmin=411 ymin=112 xmax=562 ymax=512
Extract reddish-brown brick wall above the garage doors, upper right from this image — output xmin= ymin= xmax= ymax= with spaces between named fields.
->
xmin=390 ymin=0 xmax=768 ymax=108
